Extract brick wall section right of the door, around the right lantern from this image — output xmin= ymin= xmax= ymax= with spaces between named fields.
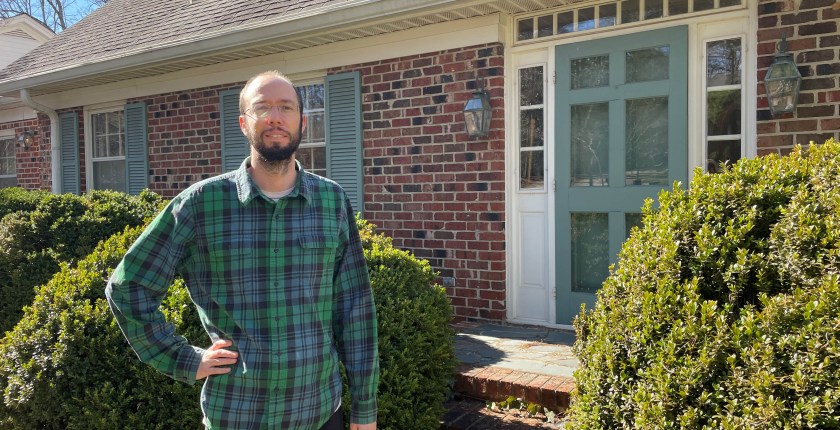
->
xmin=757 ymin=0 xmax=840 ymax=155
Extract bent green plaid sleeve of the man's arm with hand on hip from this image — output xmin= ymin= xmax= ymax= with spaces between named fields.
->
xmin=105 ymin=198 xmax=205 ymax=383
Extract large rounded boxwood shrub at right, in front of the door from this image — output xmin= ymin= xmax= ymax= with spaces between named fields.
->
xmin=567 ymin=141 xmax=840 ymax=429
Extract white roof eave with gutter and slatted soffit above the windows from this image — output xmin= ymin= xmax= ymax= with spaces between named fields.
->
xmin=0 ymin=0 xmax=578 ymax=97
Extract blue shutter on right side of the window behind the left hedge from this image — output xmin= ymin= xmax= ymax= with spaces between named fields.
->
xmin=125 ymin=103 xmax=149 ymax=195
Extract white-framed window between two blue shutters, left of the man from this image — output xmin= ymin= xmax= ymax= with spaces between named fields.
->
xmin=90 ymin=109 xmax=127 ymax=192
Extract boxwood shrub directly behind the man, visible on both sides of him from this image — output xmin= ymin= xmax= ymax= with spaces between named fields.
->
xmin=0 ymin=213 xmax=455 ymax=430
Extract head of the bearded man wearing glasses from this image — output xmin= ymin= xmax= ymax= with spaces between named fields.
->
xmin=239 ymin=77 xmax=306 ymax=164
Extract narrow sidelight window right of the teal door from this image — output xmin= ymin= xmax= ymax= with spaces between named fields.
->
xmin=704 ymin=37 xmax=744 ymax=173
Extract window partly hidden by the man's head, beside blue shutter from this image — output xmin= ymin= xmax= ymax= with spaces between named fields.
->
xmin=295 ymin=84 xmax=327 ymax=176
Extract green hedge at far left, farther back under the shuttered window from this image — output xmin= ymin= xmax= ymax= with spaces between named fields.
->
xmin=0 ymin=188 xmax=161 ymax=333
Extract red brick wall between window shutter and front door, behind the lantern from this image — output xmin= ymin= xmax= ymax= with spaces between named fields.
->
xmin=329 ymin=44 xmax=505 ymax=320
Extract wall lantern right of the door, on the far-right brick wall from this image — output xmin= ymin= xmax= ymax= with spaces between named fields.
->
xmin=764 ymin=34 xmax=802 ymax=116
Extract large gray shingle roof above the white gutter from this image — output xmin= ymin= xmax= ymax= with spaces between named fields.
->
xmin=0 ymin=0 xmax=342 ymax=81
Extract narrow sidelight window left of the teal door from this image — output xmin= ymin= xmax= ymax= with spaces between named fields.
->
xmin=519 ymin=66 xmax=545 ymax=189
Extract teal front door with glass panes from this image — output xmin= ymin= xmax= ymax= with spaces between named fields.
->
xmin=554 ymin=26 xmax=688 ymax=324
